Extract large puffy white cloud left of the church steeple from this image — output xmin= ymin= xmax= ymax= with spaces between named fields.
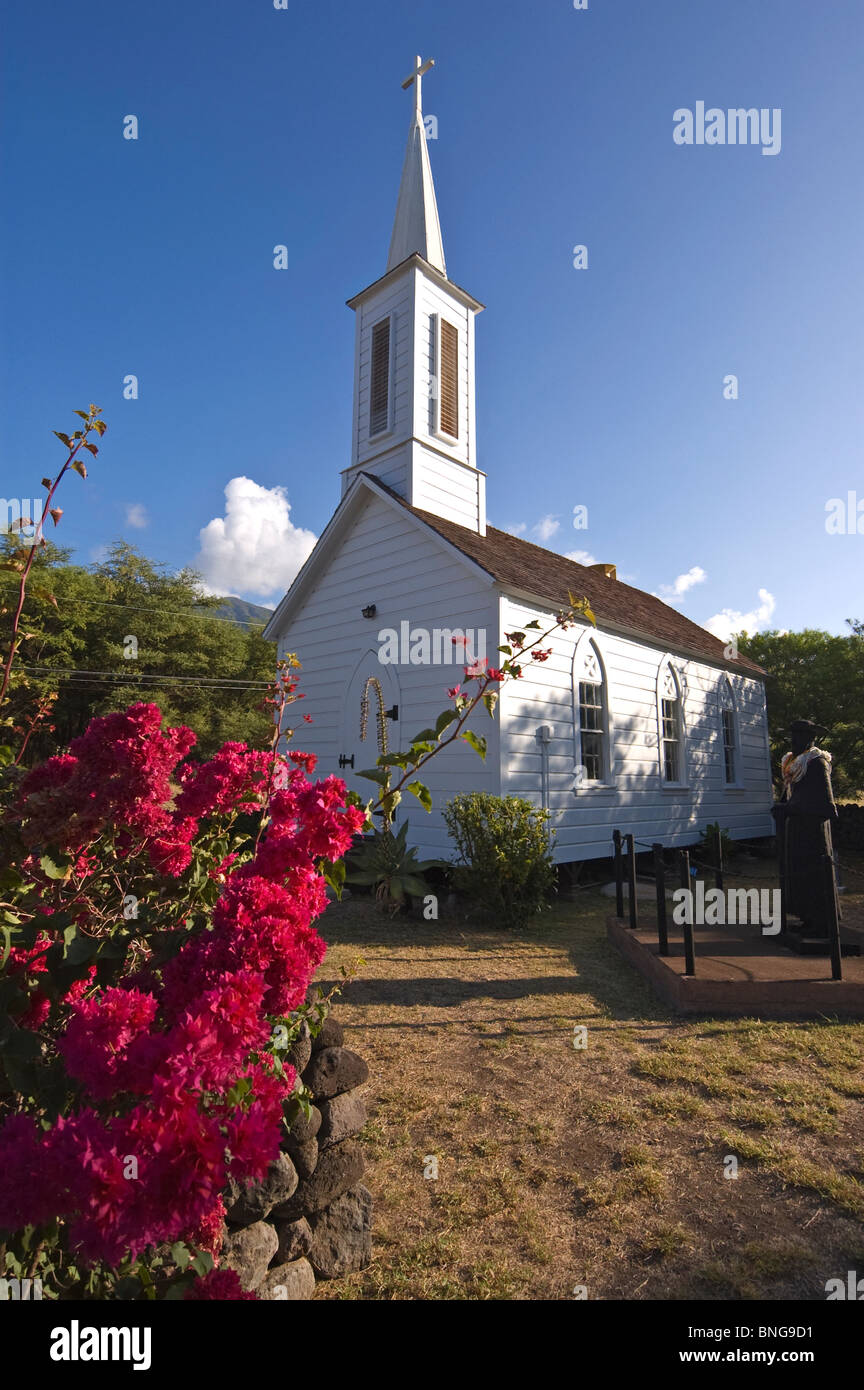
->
xmin=196 ymin=478 xmax=317 ymax=599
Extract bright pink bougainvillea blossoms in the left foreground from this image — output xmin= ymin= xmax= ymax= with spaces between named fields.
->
xmin=0 ymin=703 xmax=355 ymax=1273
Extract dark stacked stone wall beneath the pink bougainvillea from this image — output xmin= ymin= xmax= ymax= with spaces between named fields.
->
xmin=219 ymin=1015 xmax=372 ymax=1300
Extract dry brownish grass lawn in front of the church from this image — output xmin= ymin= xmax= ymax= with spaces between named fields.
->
xmin=317 ymin=856 xmax=864 ymax=1301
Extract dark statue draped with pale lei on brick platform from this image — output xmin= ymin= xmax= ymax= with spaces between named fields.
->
xmin=772 ymin=719 xmax=840 ymax=940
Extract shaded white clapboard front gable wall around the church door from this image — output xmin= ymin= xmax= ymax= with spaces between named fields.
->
xmin=273 ymin=495 xmax=500 ymax=858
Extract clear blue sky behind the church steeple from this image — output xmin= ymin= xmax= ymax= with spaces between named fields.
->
xmin=0 ymin=0 xmax=864 ymax=631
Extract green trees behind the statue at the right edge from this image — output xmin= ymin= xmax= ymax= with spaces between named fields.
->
xmin=738 ymin=619 xmax=864 ymax=798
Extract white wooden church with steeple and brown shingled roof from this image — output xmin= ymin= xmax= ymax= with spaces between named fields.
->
xmin=265 ymin=58 xmax=774 ymax=863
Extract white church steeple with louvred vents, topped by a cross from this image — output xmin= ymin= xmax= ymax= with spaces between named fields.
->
xmin=342 ymin=58 xmax=486 ymax=535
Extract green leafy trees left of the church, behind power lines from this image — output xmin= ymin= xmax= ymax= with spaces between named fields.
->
xmin=0 ymin=541 xmax=276 ymax=763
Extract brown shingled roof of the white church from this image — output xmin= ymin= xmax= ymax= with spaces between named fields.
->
xmin=374 ymin=478 xmax=765 ymax=676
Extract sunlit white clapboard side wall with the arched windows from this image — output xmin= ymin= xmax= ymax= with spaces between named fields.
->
xmin=500 ymin=596 xmax=772 ymax=862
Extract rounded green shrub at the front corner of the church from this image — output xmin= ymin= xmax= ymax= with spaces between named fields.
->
xmin=445 ymin=791 xmax=554 ymax=927
